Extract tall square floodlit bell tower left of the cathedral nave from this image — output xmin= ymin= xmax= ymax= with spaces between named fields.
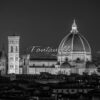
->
xmin=8 ymin=35 xmax=20 ymax=74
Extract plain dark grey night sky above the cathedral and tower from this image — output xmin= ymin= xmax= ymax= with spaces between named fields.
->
xmin=0 ymin=0 xmax=100 ymax=54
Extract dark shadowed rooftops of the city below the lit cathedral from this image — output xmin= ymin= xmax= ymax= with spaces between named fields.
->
xmin=0 ymin=74 xmax=100 ymax=100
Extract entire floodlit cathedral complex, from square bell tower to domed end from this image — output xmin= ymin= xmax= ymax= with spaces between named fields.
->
xmin=0 ymin=20 xmax=97 ymax=75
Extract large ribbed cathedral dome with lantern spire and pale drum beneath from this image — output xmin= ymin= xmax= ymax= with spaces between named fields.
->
xmin=58 ymin=21 xmax=91 ymax=61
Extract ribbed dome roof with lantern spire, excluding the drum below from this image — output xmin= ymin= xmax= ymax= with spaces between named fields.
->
xmin=58 ymin=20 xmax=91 ymax=54
